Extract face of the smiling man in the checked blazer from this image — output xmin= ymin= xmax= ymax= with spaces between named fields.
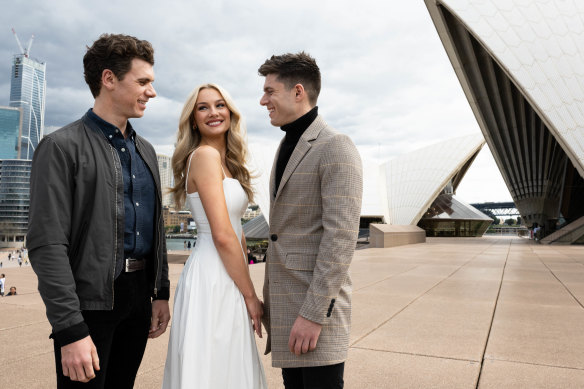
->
xmin=260 ymin=74 xmax=299 ymax=127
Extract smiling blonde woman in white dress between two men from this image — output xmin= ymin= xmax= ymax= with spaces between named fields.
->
xmin=162 ymin=84 xmax=267 ymax=389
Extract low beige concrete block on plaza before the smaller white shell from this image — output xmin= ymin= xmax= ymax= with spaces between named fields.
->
xmin=369 ymin=224 xmax=426 ymax=248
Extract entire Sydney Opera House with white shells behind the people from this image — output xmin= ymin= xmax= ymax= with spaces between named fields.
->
xmin=252 ymin=0 xmax=584 ymax=244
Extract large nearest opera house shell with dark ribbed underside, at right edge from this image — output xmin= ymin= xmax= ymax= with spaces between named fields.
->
xmin=425 ymin=0 xmax=584 ymax=236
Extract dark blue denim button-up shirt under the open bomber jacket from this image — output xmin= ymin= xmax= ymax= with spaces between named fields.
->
xmin=87 ymin=109 xmax=156 ymax=277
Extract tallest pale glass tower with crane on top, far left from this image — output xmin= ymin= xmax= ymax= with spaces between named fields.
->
xmin=10 ymin=54 xmax=46 ymax=159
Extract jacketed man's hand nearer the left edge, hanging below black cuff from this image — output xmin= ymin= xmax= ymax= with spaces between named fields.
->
xmin=61 ymin=336 xmax=99 ymax=382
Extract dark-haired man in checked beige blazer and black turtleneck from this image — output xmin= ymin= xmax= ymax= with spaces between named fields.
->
xmin=258 ymin=52 xmax=363 ymax=389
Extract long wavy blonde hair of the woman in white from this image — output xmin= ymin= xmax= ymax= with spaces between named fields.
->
xmin=170 ymin=83 xmax=253 ymax=209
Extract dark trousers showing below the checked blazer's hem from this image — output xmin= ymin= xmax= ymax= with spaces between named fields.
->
xmin=282 ymin=362 xmax=345 ymax=389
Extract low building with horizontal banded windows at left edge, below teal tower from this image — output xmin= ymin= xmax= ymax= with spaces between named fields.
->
xmin=0 ymin=159 xmax=32 ymax=246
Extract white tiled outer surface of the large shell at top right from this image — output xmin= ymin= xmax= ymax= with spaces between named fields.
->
xmin=425 ymin=0 xmax=584 ymax=176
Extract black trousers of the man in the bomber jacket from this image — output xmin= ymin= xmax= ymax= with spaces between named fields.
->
xmin=54 ymin=270 xmax=152 ymax=389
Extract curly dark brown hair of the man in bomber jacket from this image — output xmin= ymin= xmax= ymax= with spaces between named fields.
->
xmin=83 ymin=34 xmax=154 ymax=97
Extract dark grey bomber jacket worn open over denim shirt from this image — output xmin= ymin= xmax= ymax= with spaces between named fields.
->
xmin=27 ymin=115 xmax=170 ymax=346
